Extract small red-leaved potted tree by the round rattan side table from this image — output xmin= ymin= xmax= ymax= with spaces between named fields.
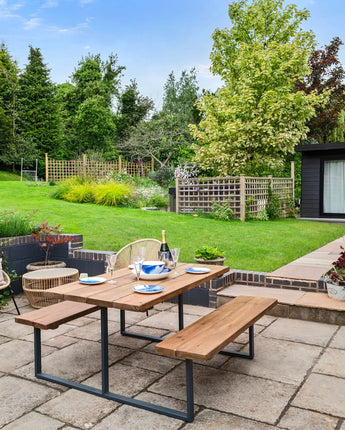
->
xmin=26 ymin=220 xmax=72 ymax=271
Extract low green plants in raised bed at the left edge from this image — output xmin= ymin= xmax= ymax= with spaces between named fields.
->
xmin=0 ymin=211 xmax=34 ymax=237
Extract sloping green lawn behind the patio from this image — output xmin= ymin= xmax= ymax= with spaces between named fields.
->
xmin=0 ymin=182 xmax=345 ymax=272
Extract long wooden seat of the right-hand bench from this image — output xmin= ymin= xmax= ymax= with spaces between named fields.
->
xmin=156 ymin=296 xmax=277 ymax=361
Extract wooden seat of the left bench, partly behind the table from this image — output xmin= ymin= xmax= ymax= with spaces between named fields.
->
xmin=15 ymin=301 xmax=99 ymax=330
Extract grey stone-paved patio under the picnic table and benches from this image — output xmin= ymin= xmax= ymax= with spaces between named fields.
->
xmin=0 ymin=296 xmax=345 ymax=430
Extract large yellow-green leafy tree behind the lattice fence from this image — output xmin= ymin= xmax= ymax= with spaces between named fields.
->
xmin=191 ymin=0 xmax=321 ymax=175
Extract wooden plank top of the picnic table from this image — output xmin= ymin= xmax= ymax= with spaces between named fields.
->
xmin=43 ymin=263 xmax=229 ymax=311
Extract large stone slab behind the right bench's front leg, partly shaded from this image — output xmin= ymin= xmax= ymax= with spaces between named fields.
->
xmin=150 ymin=365 xmax=296 ymax=424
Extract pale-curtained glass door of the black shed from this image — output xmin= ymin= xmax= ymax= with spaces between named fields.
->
xmin=323 ymin=160 xmax=345 ymax=214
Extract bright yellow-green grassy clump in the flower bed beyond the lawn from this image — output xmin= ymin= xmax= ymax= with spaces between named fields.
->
xmin=93 ymin=182 xmax=132 ymax=206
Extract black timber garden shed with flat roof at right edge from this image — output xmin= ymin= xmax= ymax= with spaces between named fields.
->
xmin=295 ymin=142 xmax=345 ymax=218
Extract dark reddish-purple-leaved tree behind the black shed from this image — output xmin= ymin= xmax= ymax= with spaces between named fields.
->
xmin=296 ymin=37 xmax=345 ymax=143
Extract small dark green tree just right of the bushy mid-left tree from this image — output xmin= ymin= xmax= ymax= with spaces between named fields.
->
xmin=116 ymin=80 xmax=154 ymax=141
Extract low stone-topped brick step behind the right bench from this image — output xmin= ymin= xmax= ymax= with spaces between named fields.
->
xmin=217 ymin=284 xmax=345 ymax=325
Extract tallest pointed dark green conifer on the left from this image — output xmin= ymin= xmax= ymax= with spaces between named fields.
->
xmin=19 ymin=46 xmax=60 ymax=158
